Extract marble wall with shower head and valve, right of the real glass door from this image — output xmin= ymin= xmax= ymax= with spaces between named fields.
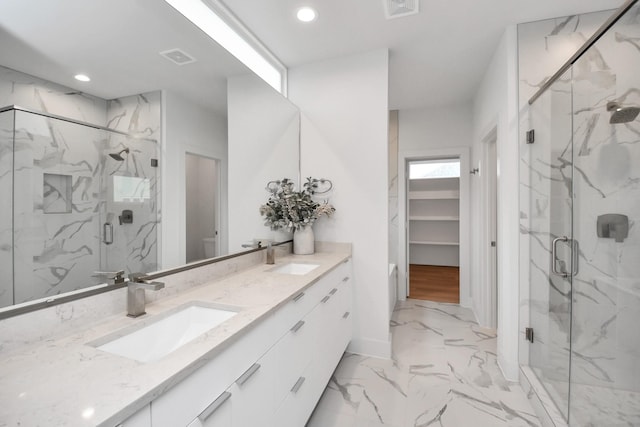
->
xmin=570 ymin=6 xmax=640 ymax=425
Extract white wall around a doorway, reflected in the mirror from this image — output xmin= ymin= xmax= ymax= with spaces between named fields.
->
xmin=161 ymin=91 xmax=227 ymax=268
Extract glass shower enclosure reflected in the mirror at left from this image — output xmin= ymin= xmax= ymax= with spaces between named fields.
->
xmin=0 ymin=107 xmax=158 ymax=307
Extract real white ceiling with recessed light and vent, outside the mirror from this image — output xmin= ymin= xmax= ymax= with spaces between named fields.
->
xmin=225 ymin=0 xmax=624 ymax=109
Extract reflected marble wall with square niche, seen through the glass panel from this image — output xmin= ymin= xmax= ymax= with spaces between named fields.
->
xmin=13 ymin=111 xmax=104 ymax=303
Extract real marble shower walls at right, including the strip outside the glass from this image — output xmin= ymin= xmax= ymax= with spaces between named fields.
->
xmin=519 ymin=7 xmax=640 ymax=426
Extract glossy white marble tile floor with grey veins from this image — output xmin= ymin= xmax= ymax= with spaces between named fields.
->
xmin=307 ymin=300 xmax=540 ymax=427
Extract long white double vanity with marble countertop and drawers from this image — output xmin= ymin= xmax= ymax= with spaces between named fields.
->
xmin=0 ymin=246 xmax=352 ymax=427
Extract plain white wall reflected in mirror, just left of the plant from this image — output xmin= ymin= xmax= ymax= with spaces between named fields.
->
xmin=227 ymin=74 xmax=300 ymax=252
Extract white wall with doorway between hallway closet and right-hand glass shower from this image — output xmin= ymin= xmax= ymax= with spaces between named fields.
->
xmin=471 ymin=26 xmax=519 ymax=380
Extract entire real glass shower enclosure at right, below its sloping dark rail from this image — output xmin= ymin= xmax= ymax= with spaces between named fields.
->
xmin=523 ymin=2 xmax=640 ymax=427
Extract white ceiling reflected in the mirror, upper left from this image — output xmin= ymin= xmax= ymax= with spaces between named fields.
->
xmin=0 ymin=0 xmax=249 ymax=116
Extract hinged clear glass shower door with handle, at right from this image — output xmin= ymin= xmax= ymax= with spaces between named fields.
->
xmin=529 ymin=70 xmax=574 ymax=419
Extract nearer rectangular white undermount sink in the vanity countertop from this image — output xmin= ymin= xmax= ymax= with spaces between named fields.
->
xmin=91 ymin=303 xmax=238 ymax=362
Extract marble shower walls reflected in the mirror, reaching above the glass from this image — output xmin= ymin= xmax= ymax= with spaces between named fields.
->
xmin=0 ymin=67 xmax=161 ymax=307
